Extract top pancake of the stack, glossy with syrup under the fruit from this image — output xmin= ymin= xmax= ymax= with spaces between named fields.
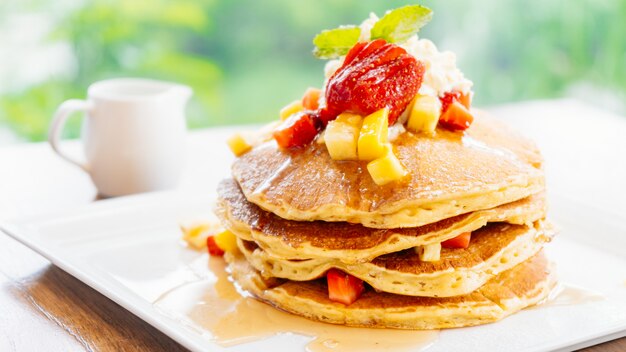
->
xmin=232 ymin=111 xmax=544 ymax=228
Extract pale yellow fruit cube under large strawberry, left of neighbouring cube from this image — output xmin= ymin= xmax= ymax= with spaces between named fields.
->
xmin=324 ymin=113 xmax=363 ymax=160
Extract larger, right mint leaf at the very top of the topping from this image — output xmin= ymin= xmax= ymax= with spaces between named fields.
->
xmin=371 ymin=5 xmax=433 ymax=43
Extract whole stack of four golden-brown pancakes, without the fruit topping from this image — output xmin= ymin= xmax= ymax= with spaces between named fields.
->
xmin=217 ymin=112 xmax=555 ymax=329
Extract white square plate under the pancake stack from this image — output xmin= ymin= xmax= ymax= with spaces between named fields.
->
xmin=2 ymin=193 xmax=626 ymax=352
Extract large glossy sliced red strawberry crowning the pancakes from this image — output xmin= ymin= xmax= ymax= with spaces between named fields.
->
xmin=326 ymin=39 xmax=424 ymax=125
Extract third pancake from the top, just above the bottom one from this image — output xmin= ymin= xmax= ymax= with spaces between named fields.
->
xmin=239 ymin=222 xmax=551 ymax=297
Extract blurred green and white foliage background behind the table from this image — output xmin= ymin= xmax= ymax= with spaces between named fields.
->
xmin=0 ymin=0 xmax=626 ymax=143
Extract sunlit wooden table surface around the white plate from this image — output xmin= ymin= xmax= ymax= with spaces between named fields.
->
xmin=0 ymin=100 xmax=626 ymax=352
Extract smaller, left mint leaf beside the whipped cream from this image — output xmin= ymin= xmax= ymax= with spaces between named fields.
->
xmin=313 ymin=26 xmax=361 ymax=59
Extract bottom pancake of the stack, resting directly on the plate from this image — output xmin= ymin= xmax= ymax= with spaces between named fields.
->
xmin=226 ymin=252 xmax=555 ymax=329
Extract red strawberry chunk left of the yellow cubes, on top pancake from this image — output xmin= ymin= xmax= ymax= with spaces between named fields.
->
xmin=274 ymin=111 xmax=321 ymax=148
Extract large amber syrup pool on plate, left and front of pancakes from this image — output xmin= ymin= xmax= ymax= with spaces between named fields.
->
xmin=154 ymin=256 xmax=439 ymax=352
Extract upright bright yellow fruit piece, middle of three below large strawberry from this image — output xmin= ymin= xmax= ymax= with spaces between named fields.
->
xmin=358 ymin=108 xmax=389 ymax=160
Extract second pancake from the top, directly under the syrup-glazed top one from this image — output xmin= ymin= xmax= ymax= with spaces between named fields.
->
xmin=216 ymin=179 xmax=546 ymax=263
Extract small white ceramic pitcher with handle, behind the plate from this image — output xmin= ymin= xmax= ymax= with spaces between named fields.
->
xmin=48 ymin=78 xmax=192 ymax=196
